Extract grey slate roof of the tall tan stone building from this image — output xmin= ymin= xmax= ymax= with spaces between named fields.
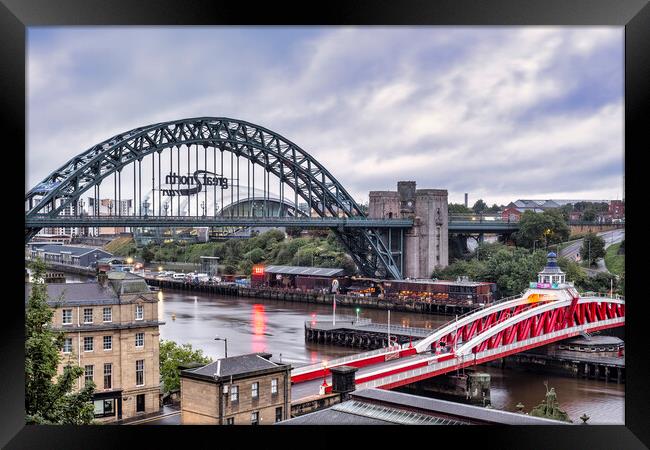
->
xmin=25 ymin=282 xmax=119 ymax=306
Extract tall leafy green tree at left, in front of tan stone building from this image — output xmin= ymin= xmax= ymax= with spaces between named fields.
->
xmin=25 ymin=259 xmax=95 ymax=425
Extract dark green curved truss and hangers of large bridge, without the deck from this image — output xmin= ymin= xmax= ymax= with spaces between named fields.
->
xmin=25 ymin=117 xmax=402 ymax=279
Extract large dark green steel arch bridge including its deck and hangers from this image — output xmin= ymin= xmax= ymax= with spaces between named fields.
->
xmin=25 ymin=117 xmax=412 ymax=279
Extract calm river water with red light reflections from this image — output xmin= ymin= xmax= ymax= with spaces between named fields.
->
xmin=68 ymin=276 xmax=625 ymax=424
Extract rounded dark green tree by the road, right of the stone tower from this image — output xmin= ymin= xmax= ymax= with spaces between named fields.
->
xmin=513 ymin=209 xmax=571 ymax=248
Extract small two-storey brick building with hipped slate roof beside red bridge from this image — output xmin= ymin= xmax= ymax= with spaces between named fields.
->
xmin=180 ymin=353 xmax=291 ymax=425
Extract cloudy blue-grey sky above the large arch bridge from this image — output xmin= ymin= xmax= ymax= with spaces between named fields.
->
xmin=26 ymin=27 xmax=624 ymax=204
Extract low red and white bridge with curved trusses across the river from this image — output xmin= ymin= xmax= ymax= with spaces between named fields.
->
xmin=291 ymin=290 xmax=625 ymax=398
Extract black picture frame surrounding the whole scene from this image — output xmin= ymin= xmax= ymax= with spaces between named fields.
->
xmin=0 ymin=0 xmax=650 ymax=450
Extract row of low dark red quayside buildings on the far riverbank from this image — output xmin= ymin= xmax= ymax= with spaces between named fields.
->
xmin=251 ymin=264 xmax=496 ymax=306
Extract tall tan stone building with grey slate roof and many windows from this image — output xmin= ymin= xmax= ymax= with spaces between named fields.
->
xmin=26 ymin=272 xmax=164 ymax=422
